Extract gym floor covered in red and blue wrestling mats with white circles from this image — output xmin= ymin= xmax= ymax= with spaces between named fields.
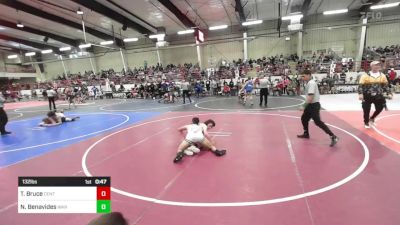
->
xmin=0 ymin=95 xmax=400 ymax=225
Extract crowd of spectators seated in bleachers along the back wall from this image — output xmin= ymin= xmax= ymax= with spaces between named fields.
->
xmin=1 ymin=46 xmax=399 ymax=102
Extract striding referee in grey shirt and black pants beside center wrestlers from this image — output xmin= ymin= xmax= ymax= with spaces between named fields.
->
xmin=297 ymin=70 xmax=338 ymax=147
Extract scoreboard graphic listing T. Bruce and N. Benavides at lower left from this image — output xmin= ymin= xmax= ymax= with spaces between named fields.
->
xmin=18 ymin=177 xmax=111 ymax=213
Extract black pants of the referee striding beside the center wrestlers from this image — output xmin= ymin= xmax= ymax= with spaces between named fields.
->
xmin=301 ymin=102 xmax=334 ymax=136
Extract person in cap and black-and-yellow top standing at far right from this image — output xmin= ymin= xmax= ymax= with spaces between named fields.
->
xmin=358 ymin=61 xmax=393 ymax=129
